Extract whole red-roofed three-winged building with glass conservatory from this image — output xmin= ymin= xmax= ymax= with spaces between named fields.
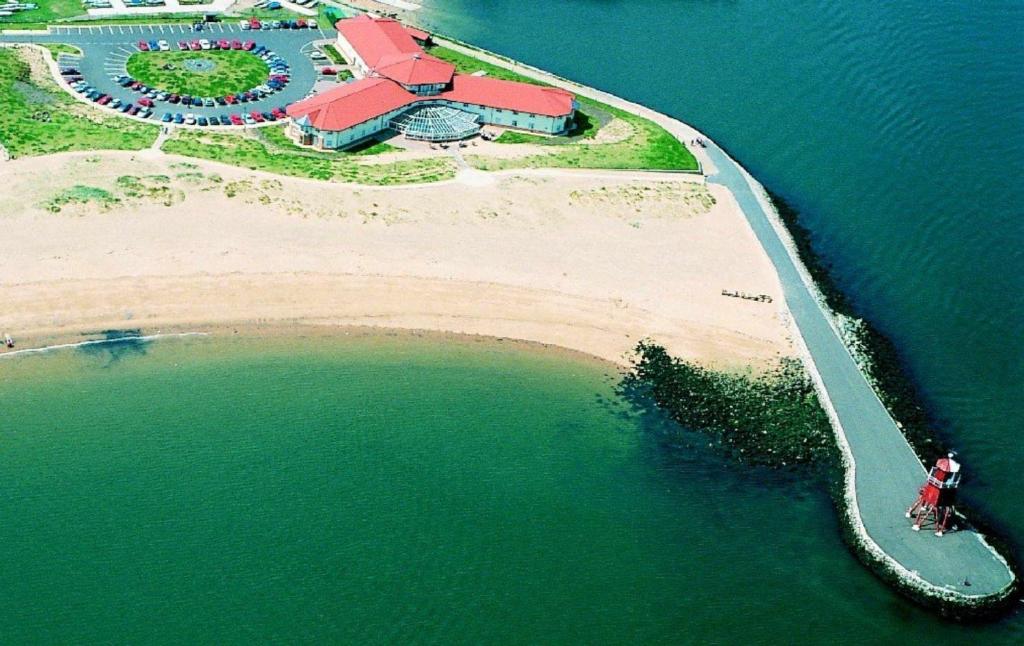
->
xmin=287 ymin=15 xmax=575 ymax=148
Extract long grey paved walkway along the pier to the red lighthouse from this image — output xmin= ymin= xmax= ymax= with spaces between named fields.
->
xmin=438 ymin=39 xmax=1013 ymax=597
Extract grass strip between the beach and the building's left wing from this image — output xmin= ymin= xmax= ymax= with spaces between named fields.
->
xmin=163 ymin=131 xmax=457 ymax=185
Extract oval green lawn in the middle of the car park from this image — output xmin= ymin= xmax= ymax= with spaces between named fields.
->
xmin=127 ymin=49 xmax=270 ymax=96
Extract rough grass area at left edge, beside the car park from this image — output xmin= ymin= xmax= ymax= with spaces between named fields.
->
xmin=0 ymin=49 xmax=159 ymax=157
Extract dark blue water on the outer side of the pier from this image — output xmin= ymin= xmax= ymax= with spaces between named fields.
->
xmin=415 ymin=0 xmax=1024 ymax=630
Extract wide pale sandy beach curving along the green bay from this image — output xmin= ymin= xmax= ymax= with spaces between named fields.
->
xmin=0 ymin=152 xmax=792 ymax=368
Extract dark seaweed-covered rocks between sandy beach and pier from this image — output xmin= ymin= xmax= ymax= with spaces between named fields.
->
xmin=623 ymin=342 xmax=837 ymax=467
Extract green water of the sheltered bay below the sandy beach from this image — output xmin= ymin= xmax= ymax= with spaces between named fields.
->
xmin=0 ymin=337 xmax=1011 ymax=644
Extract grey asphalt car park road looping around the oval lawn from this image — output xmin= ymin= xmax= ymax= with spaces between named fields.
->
xmin=0 ymin=21 xmax=336 ymax=121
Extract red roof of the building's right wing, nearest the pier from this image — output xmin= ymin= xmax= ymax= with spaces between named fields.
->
xmin=440 ymin=74 xmax=574 ymax=117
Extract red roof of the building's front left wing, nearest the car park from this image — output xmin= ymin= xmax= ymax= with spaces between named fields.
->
xmin=286 ymin=77 xmax=419 ymax=130
